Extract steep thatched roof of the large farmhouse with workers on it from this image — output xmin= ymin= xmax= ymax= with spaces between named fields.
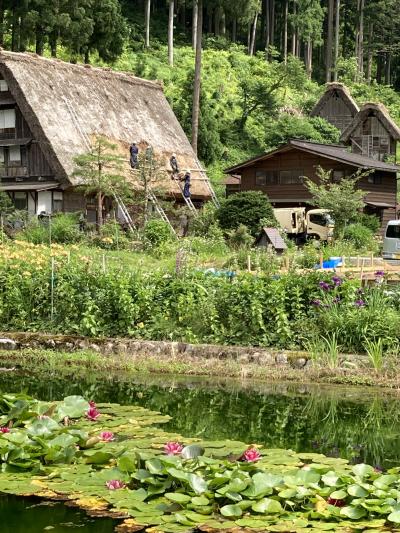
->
xmin=0 ymin=50 xmax=210 ymax=199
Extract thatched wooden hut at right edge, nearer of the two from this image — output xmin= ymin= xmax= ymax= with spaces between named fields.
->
xmin=340 ymin=103 xmax=400 ymax=161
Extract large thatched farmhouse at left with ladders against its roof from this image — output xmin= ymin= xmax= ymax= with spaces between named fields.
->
xmin=0 ymin=50 xmax=211 ymax=214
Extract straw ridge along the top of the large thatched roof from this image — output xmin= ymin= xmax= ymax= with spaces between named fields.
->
xmin=0 ymin=47 xmax=163 ymax=90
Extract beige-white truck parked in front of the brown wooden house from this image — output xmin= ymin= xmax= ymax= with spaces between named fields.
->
xmin=274 ymin=207 xmax=334 ymax=244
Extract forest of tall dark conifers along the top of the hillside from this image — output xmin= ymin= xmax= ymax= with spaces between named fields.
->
xmin=0 ymin=0 xmax=400 ymax=87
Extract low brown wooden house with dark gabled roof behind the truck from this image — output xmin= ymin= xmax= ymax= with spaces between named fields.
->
xmin=225 ymin=140 xmax=400 ymax=233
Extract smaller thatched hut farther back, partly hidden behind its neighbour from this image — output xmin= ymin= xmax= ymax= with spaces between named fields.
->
xmin=310 ymin=82 xmax=359 ymax=132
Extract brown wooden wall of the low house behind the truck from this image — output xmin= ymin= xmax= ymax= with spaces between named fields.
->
xmin=241 ymin=150 xmax=397 ymax=205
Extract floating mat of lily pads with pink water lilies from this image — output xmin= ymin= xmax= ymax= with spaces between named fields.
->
xmin=0 ymin=388 xmax=400 ymax=533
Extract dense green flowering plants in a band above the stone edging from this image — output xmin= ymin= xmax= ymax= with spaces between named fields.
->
xmin=0 ymin=243 xmax=400 ymax=354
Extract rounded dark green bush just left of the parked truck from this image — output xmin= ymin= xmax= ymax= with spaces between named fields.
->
xmin=216 ymin=191 xmax=278 ymax=237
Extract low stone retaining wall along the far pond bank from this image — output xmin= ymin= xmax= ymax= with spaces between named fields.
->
xmin=0 ymin=332 xmax=365 ymax=369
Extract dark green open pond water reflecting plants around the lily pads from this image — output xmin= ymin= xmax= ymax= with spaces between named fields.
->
xmin=0 ymin=372 xmax=400 ymax=533
